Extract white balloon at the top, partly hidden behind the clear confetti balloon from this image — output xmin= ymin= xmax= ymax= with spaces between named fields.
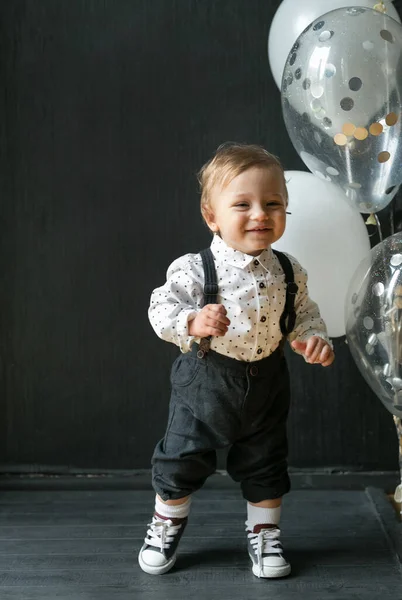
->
xmin=268 ymin=0 xmax=400 ymax=89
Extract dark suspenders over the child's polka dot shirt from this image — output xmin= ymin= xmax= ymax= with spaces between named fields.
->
xmin=197 ymin=248 xmax=298 ymax=358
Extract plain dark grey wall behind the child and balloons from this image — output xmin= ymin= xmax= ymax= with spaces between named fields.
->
xmin=0 ymin=0 xmax=397 ymax=470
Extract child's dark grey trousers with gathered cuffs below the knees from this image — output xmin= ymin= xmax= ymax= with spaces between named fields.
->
xmin=152 ymin=345 xmax=290 ymax=503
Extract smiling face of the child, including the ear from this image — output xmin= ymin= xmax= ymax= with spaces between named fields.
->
xmin=205 ymin=166 xmax=287 ymax=256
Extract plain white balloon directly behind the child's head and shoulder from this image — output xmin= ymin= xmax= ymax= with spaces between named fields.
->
xmin=273 ymin=171 xmax=370 ymax=337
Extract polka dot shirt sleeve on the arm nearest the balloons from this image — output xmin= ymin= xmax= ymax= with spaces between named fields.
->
xmin=288 ymin=256 xmax=332 ymax=354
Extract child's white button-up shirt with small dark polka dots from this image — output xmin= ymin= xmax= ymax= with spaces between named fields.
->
xmin=148 ymin=235 xmax=328 ymax=362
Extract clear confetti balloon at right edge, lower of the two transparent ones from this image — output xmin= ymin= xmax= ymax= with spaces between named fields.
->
xmin=345 ymin=233 xmax=402 ymax=417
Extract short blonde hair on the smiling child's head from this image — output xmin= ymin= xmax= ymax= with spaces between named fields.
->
xmin=198 ymin=142 xmax=287 ymax=220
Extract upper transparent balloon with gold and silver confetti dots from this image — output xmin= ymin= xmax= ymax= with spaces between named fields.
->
xmin=282 ymin=7 xmax=402 ymax=213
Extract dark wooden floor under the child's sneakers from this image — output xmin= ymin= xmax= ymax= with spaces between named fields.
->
xmin=0 ymin=489 xmax=402 ymax=600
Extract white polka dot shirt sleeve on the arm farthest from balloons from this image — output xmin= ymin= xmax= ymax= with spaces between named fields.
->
xmin=148 ymin=255 xmax=203 ymax=353
